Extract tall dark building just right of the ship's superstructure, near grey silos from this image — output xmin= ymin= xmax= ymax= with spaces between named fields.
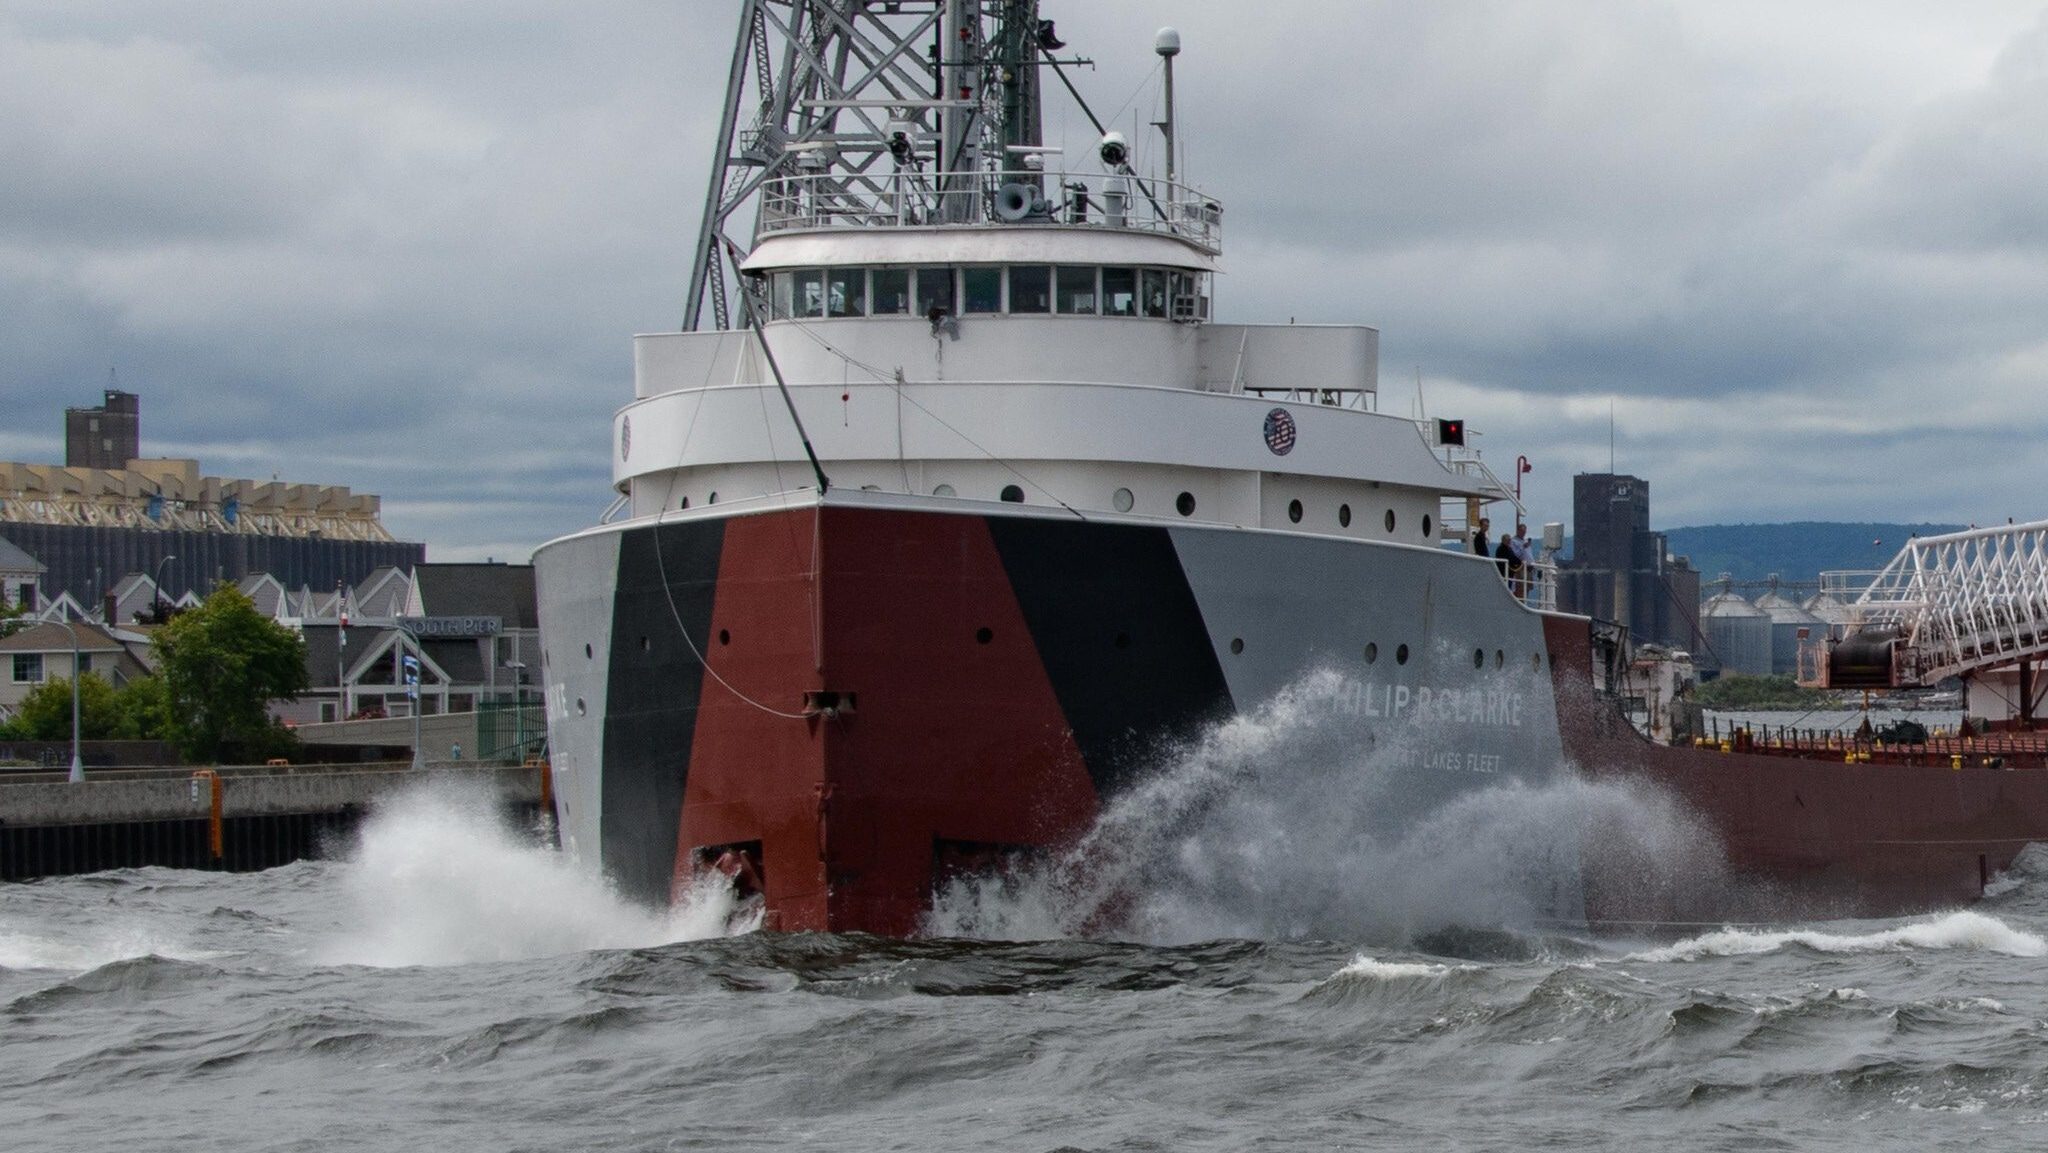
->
xmin=1556 ymin=473 xmax=1700 ymax=653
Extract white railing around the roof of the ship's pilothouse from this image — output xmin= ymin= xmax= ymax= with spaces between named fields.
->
xmin=760 ymin=170 xmax=1223 ymax=252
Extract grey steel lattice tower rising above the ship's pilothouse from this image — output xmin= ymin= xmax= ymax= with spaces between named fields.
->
xmin=682 ymin=0 xmax=1057 ymax=330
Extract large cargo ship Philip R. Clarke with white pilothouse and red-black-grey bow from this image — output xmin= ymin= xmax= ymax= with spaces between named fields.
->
xmin=535 ymin=0 xmax=2048 ymax=934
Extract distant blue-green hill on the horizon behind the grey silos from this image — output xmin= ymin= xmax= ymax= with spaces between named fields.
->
xmin=1665 ymin=520 xmax=1962 ymax=592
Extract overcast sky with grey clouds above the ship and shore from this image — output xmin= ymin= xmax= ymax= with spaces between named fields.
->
xmin=0 ymin=0 xmax=2048 ymax=559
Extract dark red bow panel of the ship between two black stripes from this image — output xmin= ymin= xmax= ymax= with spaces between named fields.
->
xmin=676 ymin=508 xmax=1096 ymax=936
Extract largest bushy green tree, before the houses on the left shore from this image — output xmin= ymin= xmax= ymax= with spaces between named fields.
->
xmin=152 ymin=584 xmax=307 ymax=762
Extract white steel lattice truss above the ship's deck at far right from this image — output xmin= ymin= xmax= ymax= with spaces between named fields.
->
xmin=1825 ymin=520 xmax=2048 ymax=686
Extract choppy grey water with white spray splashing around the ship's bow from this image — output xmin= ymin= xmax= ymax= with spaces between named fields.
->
xmin=12 ymin=712 xmax=2048 ymax=1151
